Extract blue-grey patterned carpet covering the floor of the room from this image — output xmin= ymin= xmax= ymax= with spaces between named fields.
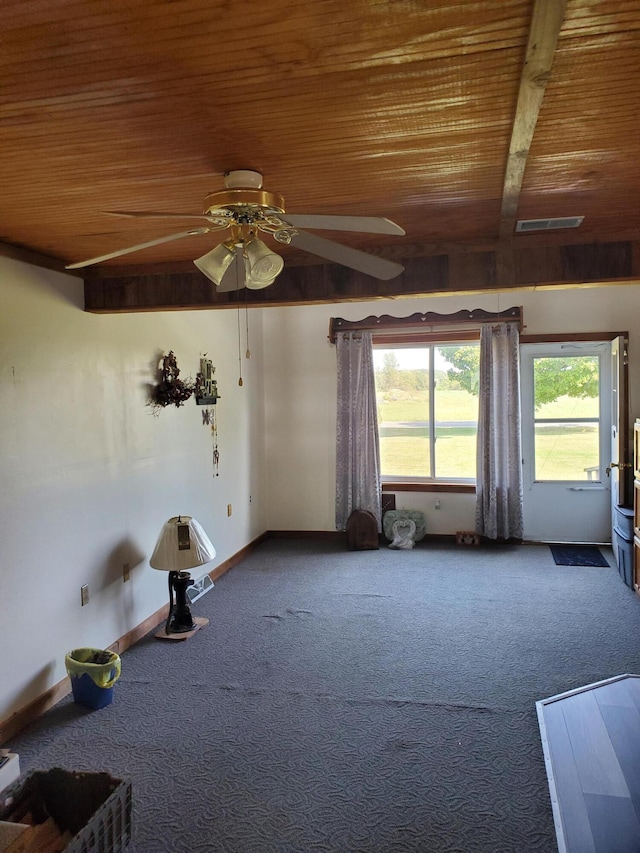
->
xmin=10 ymin=539 xmax=640 ymax=853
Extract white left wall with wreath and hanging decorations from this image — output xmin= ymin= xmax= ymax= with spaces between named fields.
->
xmin=0 ymin=258 xmax=266 ymax=720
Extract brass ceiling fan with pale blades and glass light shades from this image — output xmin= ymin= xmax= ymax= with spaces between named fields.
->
xmin=66 ymin=169 xmax=405 ymax=291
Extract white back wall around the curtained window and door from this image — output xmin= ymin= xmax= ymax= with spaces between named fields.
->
xmin=264 ymin=285 xmax=640 ymax=534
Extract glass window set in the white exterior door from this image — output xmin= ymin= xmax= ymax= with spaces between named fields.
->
xmin=533 ymin=356 xmax=601 ymax=482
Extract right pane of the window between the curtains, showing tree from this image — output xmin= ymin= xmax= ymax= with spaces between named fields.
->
xmin=434 ymin=344 xmax=480 ymax=480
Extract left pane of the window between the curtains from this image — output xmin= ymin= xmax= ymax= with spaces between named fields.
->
xmin=373 ymin=347 xmax=431 ymax=477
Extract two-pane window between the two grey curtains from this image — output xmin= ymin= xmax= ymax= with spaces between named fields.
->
xmin=373 ymin=336 xmax=480 ymax=483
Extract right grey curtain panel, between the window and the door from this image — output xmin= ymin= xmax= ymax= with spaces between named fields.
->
xmin=476 ymin=323 xmax=523 ymax=539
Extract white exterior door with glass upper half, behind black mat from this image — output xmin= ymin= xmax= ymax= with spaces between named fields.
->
xmin=521 ymin=341 xmax=613 ymax=542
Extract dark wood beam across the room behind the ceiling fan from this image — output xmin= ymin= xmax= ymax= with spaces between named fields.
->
xmin=84 ymin=236 xmax=640 ymax=314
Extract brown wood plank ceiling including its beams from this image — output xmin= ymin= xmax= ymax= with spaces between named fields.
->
xmin=0 ymin=0 xmax=640 ymax=311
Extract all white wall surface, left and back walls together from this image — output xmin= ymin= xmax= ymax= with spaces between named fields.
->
xmin=0 ymin=258 xmax=640 ymax=720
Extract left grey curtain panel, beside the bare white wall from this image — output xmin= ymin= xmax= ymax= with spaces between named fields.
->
xmin=336 ymin=331 xmax=382 ymax=531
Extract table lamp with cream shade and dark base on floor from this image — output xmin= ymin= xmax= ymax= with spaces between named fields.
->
xmin=149 ymin=515 xmax=216 ymax=639
